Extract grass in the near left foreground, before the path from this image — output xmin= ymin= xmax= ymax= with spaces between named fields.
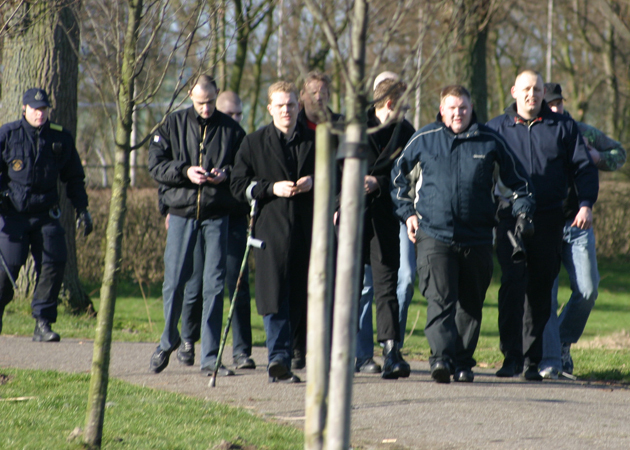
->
xmin=0 ymin=369 xmax=304 ymax=450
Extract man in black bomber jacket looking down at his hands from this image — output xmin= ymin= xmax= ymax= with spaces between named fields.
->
xmin=148 ymin=75 xmax=245 ymax=376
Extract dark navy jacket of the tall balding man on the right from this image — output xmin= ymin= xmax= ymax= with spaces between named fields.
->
xmin=488 ymin=100 xmax=599 ymax=211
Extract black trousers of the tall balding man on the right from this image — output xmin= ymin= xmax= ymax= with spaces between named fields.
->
xmin=497 ymin=209 xmax=564 ymax=365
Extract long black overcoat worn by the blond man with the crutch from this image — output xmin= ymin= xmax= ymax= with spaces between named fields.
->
xmin=231 ymin=122 xmax=315 ymax=315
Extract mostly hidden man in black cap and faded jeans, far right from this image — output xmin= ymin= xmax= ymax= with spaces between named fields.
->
xmin=540 ymin=83 xmax=626 ymax=379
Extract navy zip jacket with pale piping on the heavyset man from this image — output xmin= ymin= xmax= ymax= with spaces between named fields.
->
xmin=391 ymin=114 xmax=534 ymax=245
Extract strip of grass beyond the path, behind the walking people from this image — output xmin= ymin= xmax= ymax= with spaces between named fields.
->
xmin=3 ymin=260 xmax=630 ymax=382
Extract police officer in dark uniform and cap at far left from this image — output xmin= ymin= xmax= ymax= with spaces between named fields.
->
xmin=0 ymin=88 xmax=92 ymax=342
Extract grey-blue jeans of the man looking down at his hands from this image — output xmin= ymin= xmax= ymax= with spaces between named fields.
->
xmin=160 ymin=215 xmax=228 ymax=368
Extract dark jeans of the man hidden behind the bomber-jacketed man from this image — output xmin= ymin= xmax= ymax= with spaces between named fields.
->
xmin=182 ymin=216 xmax=252 ymax=356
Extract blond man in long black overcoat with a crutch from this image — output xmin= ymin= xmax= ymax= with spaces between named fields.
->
xmin=230 ymin=81 xmax=315 ymax=382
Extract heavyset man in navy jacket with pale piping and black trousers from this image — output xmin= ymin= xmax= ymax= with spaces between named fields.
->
xmin=391 ymin=86 xmax=534 ymax=383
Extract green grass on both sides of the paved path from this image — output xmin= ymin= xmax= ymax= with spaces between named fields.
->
xmin=0 ymin=261 xmax=630 ymax=449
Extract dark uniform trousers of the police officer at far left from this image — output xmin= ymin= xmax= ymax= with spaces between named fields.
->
xmin=0 ymin=212 xmax=67 ymax=331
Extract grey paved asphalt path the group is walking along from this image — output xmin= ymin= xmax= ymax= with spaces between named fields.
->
xmin=0 ymin=336 xmax=630 ymax=450
